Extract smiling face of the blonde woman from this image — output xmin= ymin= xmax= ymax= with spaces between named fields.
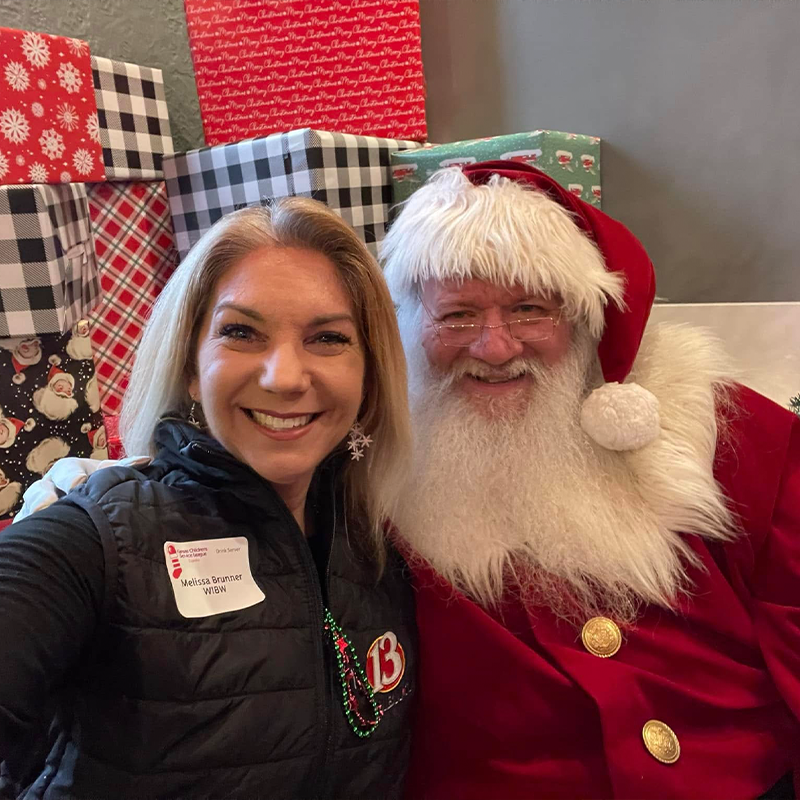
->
xmin=189 ymin=247 xmax=365 ymax=491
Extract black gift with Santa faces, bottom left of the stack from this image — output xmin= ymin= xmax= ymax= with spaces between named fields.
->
xmin=0 ymin=320 xmax=108 ymax=520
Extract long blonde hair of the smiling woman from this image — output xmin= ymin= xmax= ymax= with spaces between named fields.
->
xmin=120 ymin=197 xmax=411 ymax=563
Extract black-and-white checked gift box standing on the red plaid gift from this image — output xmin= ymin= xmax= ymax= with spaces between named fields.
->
xmin=92 ymin=56 xmax=173 ymax=181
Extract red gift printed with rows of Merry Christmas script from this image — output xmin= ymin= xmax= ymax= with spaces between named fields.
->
xmin=184 ymin=0 xmax=427 ymax=145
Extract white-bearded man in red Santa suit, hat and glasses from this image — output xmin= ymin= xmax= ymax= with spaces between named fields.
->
xmin=382 ymin=161 xmax=800 ymax=800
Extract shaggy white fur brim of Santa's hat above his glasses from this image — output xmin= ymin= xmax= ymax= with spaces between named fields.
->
xmin=381 ymin=167 xmax=624 ymax=338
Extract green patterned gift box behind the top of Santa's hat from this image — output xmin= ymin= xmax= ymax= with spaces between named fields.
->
xmin=392 ymin=130 xmax=602 ymax=208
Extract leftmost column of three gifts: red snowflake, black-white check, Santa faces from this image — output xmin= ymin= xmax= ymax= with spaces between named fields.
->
xmin=0 ymin=28 xmax=105 ymax=521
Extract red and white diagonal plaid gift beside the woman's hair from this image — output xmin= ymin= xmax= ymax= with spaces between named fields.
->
xmin=89 ymin=181 xmax=176 ymax=415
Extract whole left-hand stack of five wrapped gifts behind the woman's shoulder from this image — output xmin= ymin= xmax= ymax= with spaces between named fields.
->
xmin=0 ymin=28 xmax=175 ymax=524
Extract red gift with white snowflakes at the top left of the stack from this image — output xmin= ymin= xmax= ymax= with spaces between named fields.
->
xmin=0 ymin=28 xmax=105 ymax=184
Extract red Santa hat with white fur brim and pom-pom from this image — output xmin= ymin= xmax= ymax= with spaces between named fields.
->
xmin=381 ymin=161 xmax=660 ymax=450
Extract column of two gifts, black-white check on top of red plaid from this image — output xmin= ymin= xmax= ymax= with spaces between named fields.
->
xmin=89 ymin=51 xmax=175 ymax=414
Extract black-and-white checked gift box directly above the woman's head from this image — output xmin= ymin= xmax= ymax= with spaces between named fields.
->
xmin=164 ymin=128 xmax=421 ymax=258
